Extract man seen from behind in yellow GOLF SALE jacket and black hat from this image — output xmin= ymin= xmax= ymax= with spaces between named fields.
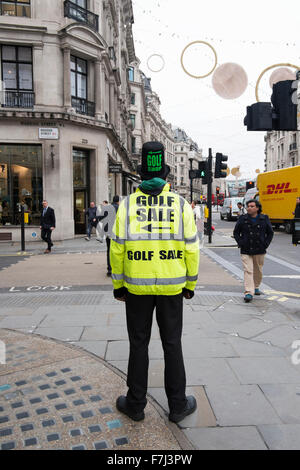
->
xmin=110 ymin=142 xmax=199 ymax=423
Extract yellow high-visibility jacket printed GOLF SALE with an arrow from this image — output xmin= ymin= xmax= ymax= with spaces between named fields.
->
xmin=110 ymin=184 xmax=200 ymax=295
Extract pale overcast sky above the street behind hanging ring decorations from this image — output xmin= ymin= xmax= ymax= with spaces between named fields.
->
xmin=133 ymin=0 xmax=300 ymax=178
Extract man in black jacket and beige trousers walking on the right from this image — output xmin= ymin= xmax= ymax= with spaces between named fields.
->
xmin=233 ymin=199 xmax=274 ymax=303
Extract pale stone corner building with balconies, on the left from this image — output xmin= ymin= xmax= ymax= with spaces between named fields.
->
xmin=0 ymin=0 xmax=137 ymax=240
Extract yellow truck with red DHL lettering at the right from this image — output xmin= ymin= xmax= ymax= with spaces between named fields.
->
xmin=256 ymin=166 xmax=300 ymax=233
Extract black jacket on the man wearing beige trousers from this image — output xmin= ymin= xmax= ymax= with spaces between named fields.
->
xmin=233 ymin=214 xmax=274 ymax=255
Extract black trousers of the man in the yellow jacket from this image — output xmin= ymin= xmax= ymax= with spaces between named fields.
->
xmin=126 ymin=293 xmax=186 ymax=413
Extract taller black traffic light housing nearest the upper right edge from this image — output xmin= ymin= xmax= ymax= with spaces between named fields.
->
xmin=271 ymin=80 xmax=297 ymax=131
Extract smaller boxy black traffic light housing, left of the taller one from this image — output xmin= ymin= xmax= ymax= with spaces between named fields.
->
xmin=244 ymin=103 xmax=273 ymax=131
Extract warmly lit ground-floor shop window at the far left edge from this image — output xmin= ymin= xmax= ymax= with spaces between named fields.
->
xmin=0 ymin=144 xmax=43 ymax=226
